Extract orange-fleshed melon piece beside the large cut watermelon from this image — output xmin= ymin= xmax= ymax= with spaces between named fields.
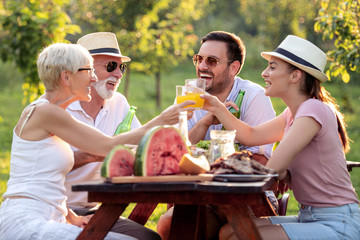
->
xmin=179 ymin=153 xmax=210 ymax=174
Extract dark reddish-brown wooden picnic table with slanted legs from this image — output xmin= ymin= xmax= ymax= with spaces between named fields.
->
xmin=72 ymin=174 xmax=274 ymax=240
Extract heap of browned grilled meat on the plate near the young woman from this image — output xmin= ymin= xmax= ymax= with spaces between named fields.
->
xmin=208 ymin=150 xmax=276 ymax=175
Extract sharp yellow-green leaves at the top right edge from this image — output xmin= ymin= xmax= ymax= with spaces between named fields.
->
xmin=314 ymin=0 xmax=360 ymax=83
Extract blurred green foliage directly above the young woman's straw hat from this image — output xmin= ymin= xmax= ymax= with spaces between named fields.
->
xmin=238 ymin=0 xmax=319 ymax=47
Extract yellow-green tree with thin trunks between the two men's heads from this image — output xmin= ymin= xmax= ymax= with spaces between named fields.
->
xmin=68 ymin=0 xmax=209 ymax=108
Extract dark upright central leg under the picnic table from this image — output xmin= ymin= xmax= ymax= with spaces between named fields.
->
xmin=169 ymin=204 xmax=206 ymax=240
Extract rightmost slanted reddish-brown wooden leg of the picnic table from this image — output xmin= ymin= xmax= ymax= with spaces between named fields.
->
xmin=222 ymin=205 xmax=261 ymax=240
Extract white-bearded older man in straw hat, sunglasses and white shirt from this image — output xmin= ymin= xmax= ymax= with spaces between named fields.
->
xmin=65 ymin=32 xmax=160 ymax=240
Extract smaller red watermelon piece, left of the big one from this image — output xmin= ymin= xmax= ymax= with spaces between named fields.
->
xmin=101 ymin=145 xmax=135 ymax=178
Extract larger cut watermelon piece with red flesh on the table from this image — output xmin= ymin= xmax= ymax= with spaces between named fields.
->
xmin=134 ymin=126 xmax=189 ymax=176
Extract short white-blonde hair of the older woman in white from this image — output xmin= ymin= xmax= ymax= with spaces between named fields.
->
xmin=37 ymin=43 xmax=93 ymax=91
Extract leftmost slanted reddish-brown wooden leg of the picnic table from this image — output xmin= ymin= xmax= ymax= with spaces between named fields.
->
xmin=76 ymin=203 xmax=128 ymax=240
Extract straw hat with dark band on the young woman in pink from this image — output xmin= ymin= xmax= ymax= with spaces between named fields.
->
xmin=261 ymin=35 xmax=328 ymax=82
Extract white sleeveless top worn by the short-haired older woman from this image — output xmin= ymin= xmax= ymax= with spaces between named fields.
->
xmin=3 ymin=99 xmax=74 ymax=215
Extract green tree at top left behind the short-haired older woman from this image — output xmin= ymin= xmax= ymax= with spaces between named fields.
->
xmin=0 ymin=0 xmax=80 ymax=103
